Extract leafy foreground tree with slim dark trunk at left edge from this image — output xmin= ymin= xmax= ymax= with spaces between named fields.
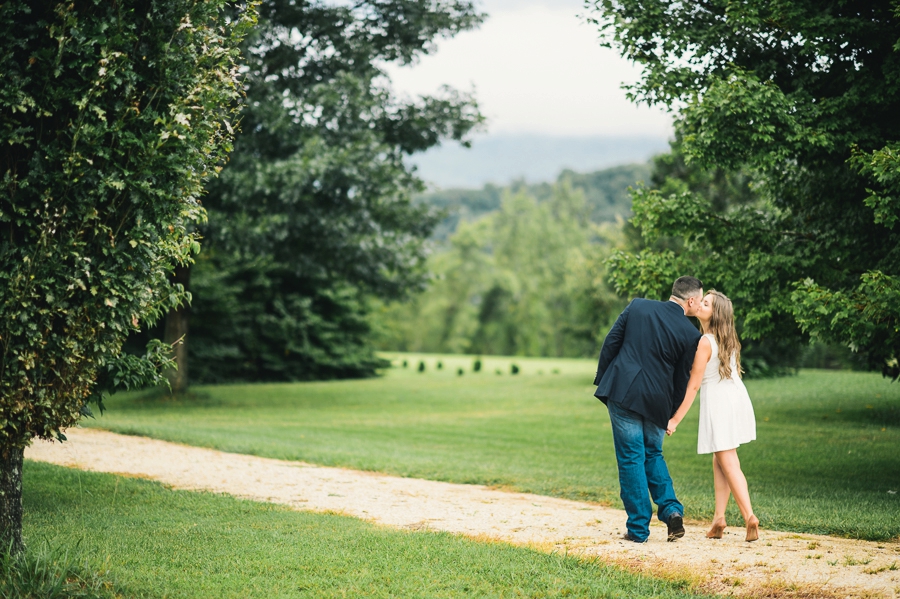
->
xmin=0 ymin=0 xmax=252 ymax=552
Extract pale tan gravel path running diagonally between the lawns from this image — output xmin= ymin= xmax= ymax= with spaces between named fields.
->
xmin=25 ymin=429 xmax=900 ymax=599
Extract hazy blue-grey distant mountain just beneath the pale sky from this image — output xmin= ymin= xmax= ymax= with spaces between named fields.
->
xmin=411 ymin=135 xmax=669 ymax=189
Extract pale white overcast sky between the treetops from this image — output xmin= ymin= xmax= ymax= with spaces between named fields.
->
xmin=389 ymin=0 xmax=671 ymax=138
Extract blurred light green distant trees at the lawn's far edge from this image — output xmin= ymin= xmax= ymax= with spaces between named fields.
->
xmin=373 ymin=182 xmax=624 ymax=357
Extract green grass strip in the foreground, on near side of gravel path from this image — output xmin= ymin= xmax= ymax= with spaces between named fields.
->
xmin=21 ymin=462 xmax=712 ymax=599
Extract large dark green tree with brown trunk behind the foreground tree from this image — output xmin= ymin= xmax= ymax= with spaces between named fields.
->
xmin=160 ymin=0 xmax=482 ymax=388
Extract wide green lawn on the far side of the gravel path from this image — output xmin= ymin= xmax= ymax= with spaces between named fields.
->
xmin=87 ymin=355 xmax=900 ymax=540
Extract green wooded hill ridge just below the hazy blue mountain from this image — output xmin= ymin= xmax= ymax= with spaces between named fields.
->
xmin=416 ymin=162 xmax=650 ymax=241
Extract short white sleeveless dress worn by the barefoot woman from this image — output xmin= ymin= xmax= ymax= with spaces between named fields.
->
xmin=697 ymin=333 xmax=756 ymax=453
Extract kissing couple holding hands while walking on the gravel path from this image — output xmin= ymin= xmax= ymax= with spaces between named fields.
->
xmin=594 ymin=277 xmax=759 ymax=543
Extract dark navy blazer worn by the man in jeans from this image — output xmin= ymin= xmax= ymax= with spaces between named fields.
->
xmin=594 ymin=299 xmax=700 ymax=428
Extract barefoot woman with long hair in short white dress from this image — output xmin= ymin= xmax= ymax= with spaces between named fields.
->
xmin=666 ymin=290 xmax=759 ymax=541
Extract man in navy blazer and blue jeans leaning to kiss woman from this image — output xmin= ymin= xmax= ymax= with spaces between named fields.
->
xmin=594 ymin=277 xmax=703 ymax=543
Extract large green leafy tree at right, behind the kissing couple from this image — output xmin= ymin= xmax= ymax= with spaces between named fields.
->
xmin=588 ymin=0 xmax=900 ymax=378
